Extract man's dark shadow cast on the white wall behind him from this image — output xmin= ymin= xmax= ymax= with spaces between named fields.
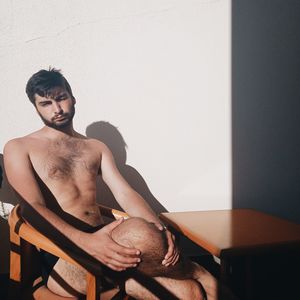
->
xmin=86 ymin=121 xmax=167 ymax=214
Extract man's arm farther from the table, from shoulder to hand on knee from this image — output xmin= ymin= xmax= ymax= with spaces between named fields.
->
xmin=4 ymin=139 xmax=139 ymax=271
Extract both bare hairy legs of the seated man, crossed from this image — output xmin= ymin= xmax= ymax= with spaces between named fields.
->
xmin=42 ymin=218 xmax=217 ymax=300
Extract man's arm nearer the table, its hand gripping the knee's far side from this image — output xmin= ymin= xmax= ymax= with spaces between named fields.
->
xmin=101 ymin=145 xmax=179 ymax=266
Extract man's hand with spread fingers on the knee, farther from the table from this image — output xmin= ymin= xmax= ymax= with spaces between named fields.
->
xmin=90 ymin=219 xmax=141 ymax=271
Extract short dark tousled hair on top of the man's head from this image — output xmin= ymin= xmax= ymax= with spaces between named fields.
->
xmin=26 ymin=68 xmax=74 ymax=105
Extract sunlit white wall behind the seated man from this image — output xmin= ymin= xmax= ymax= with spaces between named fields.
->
xmin=0 ymin=0 xmax=231 ymax=211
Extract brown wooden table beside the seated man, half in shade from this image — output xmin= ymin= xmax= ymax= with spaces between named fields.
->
xmin=160 ymin=209 xmax=300 ymax=299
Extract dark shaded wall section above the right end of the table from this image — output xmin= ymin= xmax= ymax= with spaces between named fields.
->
xmin=232 ymin=0 xmax=300 ymax=223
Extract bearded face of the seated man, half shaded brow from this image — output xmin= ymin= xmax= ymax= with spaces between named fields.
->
xmin=35 ymin=87 xmax=75 ymax=129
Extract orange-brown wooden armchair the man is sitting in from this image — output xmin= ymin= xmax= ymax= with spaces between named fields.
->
xmin=8 ymin=205 xmax=128 ymax=300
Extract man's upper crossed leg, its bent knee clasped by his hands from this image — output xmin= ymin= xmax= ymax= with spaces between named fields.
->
xmin=112 ymin=218 xmax=218 ymax=300
